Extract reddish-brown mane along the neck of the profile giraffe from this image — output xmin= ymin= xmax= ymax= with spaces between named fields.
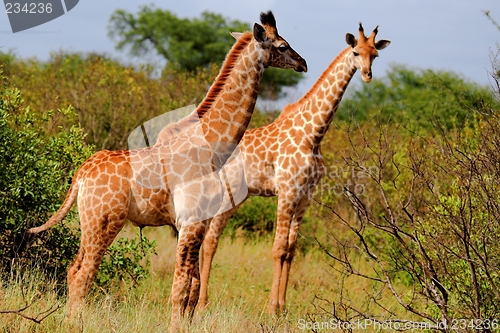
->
xmin=196 ymin=32 xmax=253 ymax=118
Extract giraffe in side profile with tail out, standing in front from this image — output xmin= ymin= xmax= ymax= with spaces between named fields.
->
xmin=21 ymin=11 xmax=307 ymax=332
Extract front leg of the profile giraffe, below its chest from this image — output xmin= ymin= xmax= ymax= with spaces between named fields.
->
xmin=170 ymin=221 xmax=207 ymax=332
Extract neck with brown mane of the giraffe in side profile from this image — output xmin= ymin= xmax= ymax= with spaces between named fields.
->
xmin=155 ymin=32 xmax=265 ymax=169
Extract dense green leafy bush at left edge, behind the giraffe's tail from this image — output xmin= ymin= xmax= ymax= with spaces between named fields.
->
xmin=0 ymin=72 xmax=92 ymax=273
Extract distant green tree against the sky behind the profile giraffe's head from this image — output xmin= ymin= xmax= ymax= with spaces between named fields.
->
xmin=108 ymin=6 xmax=303 ymax=99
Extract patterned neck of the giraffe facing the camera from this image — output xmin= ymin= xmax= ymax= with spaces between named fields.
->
xmin=280 ymin=47 xmax=356 ymax=145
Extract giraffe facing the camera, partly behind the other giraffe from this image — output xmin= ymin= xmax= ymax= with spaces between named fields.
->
xmin=199 ymin=23 xmax=390 ymax=313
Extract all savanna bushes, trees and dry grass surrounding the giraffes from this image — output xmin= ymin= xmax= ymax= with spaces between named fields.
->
xmin=0 ymin=7 xmax=500 ymax=332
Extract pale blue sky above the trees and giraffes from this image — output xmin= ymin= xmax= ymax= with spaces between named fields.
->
xmin=0 ymin=0 xmax=500 ymax=102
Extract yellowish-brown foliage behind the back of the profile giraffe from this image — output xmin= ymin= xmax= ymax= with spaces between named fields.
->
xmin=0 ymin=53 xmax=217 ymax=150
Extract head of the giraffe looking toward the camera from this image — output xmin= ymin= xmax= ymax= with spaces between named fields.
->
xmin=345 ymin=23 xmax=391 ymax=82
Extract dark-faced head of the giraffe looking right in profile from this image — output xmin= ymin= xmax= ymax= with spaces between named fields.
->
xmin=233 ymin=11 xmax=307 ymax=72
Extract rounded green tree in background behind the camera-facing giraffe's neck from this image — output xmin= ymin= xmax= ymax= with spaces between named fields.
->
xmin=338 ymin=66 xmax=498 ymax=129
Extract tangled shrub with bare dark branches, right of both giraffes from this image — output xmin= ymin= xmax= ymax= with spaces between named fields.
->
xmin=314 ymin=99 xmax=500 ymax=331
